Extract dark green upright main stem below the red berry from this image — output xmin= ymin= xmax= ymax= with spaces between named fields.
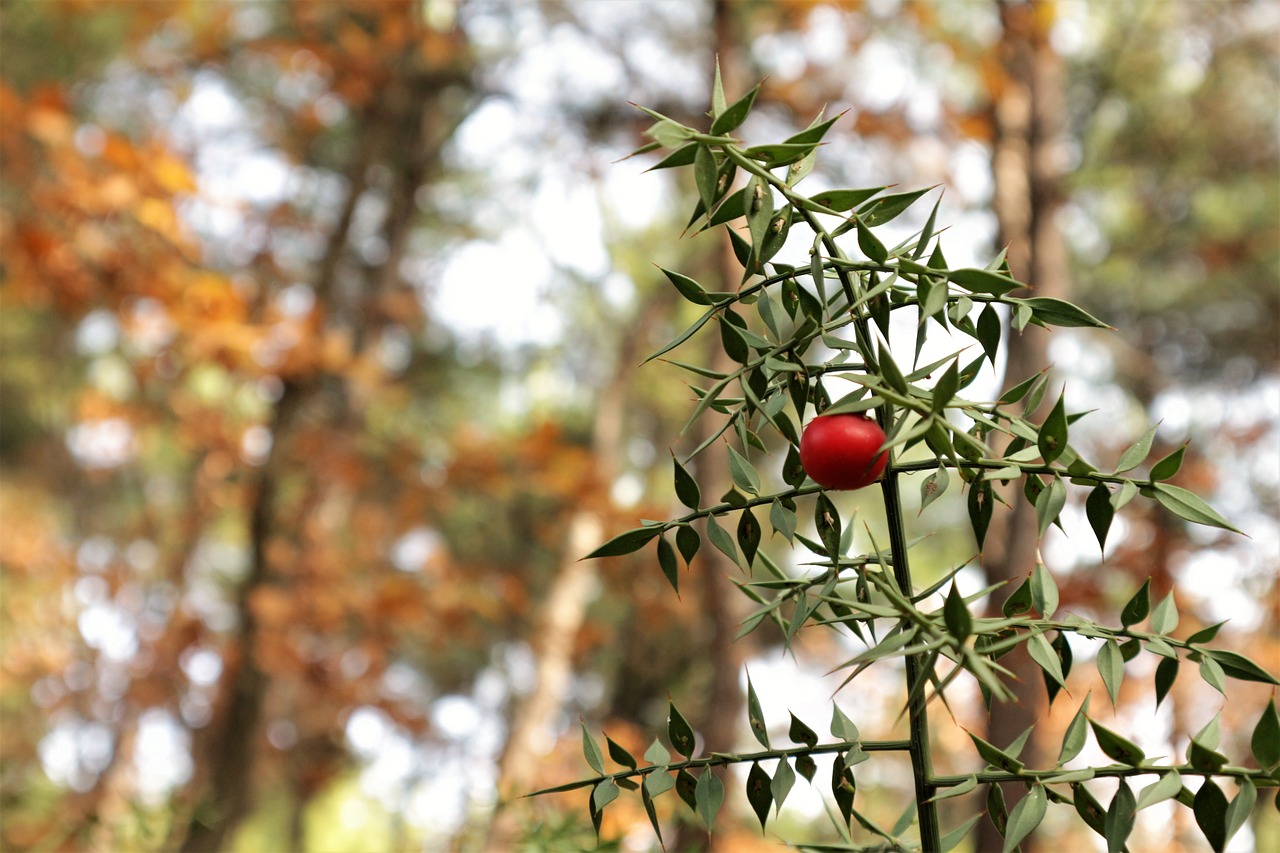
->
xmin=881 ymin=471 xmax=942 ymax=853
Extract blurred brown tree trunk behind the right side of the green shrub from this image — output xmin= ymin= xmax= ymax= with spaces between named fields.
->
xmin=977 ymin=0 xmax=1070 ymax=850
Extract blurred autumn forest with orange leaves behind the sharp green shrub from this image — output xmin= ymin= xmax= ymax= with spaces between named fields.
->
xmin=0 ymin=0 xmax=1280 ymax=850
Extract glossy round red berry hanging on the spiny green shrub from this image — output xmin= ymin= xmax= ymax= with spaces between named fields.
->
xmin=800 ymin=415 xmax=888 ymax=489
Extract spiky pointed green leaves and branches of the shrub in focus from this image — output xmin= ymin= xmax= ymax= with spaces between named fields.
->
xmin=529 ymin=76 xmax=1280 ymax=852
